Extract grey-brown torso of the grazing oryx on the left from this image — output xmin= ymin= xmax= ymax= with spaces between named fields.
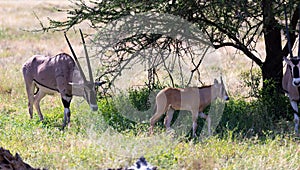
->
xmin=23 ymin=53 xmax=75 ymax=95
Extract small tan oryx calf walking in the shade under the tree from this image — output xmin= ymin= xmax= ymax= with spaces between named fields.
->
xmin=150 ymin=78 xmax=229 ymax=137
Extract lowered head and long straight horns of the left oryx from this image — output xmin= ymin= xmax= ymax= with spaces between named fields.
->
xmin=65 ymin=30 xmax=99 ymax=111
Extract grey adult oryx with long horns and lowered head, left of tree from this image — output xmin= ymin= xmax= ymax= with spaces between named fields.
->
xmin=22 ymin=31 xmax=101 ymax=128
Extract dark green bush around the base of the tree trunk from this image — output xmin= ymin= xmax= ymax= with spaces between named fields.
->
xmin=218 ymin=74 xmax=293 ymax=136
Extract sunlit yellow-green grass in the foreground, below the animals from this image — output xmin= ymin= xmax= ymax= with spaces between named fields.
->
xmin=0 ymin=87 xmax=300 ymax=170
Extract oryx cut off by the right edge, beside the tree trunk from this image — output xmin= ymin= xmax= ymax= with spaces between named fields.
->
xmin=282 ymin=4 xmax=300 ymax=134
